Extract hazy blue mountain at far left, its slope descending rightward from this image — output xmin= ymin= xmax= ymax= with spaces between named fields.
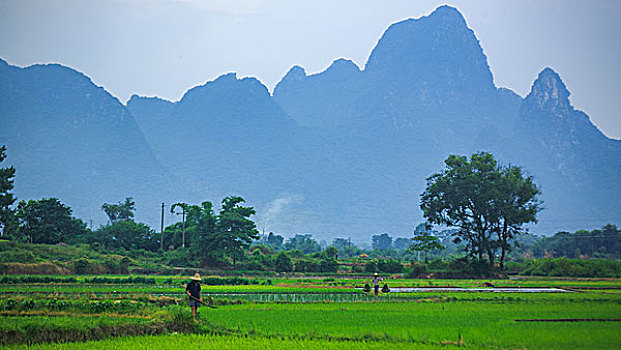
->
xmin=0 ymin=60 xmax=183 ymax=225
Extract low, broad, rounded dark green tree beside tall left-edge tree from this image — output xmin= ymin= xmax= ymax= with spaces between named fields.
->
xmin=16 ymin=198 xmax=87 ymax=244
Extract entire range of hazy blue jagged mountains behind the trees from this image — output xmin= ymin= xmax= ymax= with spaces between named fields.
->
xmin=0 ymin=6 xmax=621 ymax=240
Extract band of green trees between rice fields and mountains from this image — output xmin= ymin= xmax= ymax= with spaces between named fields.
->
xmin=0 ymin=146 xmax=621 ymax=272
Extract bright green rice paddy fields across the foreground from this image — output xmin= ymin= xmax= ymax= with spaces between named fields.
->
xmin=0 ymin=278 xmax=621 ymax=349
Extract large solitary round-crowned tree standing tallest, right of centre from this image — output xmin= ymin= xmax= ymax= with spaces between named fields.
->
xmin=420 ymin=152 xmax=541 ymax=268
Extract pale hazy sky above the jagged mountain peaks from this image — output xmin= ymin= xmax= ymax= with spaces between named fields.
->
xmin=0 ymin=0 xmax=621 ymax=139
